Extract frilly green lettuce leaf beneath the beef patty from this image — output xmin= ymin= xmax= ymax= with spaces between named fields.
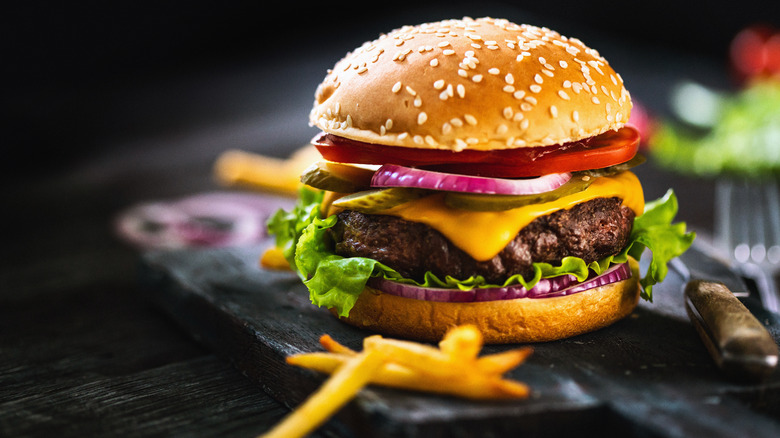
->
xmin=268 ymin=187 xmax=694 ymax=316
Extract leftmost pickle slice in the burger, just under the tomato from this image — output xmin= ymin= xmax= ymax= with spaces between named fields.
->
xmin=301 ymin=161 xmax=374 ymax=193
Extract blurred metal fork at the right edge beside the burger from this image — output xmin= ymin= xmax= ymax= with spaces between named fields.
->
xmin=714 ymin=180 xmax=780 ymax=312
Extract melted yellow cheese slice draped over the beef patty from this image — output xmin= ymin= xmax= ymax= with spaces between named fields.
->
xmin=377 ymin=172 xmax=645 ymax=261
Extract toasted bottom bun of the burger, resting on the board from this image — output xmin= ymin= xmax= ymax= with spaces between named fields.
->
xmin=340 ymin=259 xmax=639 ymax=344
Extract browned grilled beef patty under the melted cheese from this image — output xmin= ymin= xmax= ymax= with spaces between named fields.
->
xmin=331 ymin=198 xmax=634 ymax=283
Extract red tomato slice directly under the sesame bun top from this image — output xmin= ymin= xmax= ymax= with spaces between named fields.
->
xmin=312 ymin=126 xmax=639 ymax=178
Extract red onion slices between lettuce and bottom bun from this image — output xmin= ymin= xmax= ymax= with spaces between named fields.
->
xmin=369 ymin=263 xmax=631 ymax=303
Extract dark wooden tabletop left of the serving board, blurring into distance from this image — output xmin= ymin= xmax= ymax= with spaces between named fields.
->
xmin=0 ymin=5 xmax=772 ymax=437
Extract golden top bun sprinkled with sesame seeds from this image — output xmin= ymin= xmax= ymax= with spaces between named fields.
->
xmin=310 ymin=18 xmax=631 ymax=151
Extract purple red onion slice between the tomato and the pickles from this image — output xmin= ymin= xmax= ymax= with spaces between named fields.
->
xmin=371 ymin=164 xmax=571 ymax=195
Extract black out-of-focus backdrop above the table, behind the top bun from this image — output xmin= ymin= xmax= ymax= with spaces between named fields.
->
xmin=0 ymin=0 xmax=780 ymax=181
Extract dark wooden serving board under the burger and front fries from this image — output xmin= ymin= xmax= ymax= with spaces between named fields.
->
xmin=142 ymin=241 xmax=780 ymax=438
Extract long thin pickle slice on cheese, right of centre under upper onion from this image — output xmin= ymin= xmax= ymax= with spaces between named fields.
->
xmin=444 ymin=174 xmax=596 ymax=211
